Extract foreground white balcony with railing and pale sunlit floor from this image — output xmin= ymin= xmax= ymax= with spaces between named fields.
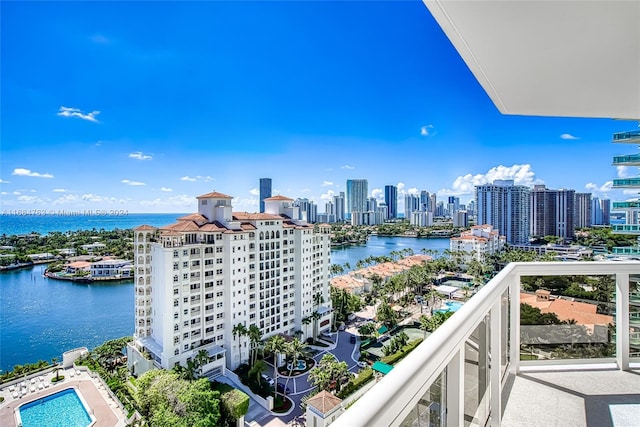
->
xmin=332 ymin=262 xmax=640 ymax=427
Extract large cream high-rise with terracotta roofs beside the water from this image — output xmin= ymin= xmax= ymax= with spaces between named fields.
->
xmin=128 ymin=192 xmax=331 ymax=374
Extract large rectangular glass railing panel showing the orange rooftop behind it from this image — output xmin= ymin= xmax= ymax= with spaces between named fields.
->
xmin=520 ymin=276 xmax=616 ymax=360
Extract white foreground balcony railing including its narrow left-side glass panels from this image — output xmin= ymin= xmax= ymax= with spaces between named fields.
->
xmin=333 ymin=262 xmax=640 ymax=427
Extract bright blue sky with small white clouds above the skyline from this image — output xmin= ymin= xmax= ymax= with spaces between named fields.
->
xmin=0 ymin=1 xmax=636 ymax=213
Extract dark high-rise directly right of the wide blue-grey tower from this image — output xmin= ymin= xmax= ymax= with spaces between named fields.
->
xmin=530 ymin=185 xmax=575 ymax=240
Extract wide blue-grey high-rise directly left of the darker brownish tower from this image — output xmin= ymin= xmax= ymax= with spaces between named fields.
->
xmin=475 ymin=180 xmax=530 ymax=244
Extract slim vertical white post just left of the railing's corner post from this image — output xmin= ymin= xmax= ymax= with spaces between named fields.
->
xmin=489 ymin=298 xmax=503 ymax=427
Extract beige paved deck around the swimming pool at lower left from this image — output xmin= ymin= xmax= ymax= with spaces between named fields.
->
xmin=0 ymin=369 xmax=127 ymax=427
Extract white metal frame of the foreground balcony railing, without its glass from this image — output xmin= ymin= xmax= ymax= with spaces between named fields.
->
xmin=332 ymin=262 xmax=640 ymax=427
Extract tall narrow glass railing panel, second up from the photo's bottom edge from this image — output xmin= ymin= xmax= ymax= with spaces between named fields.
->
xmin=464 ymin=315 xmax=490 ymax=427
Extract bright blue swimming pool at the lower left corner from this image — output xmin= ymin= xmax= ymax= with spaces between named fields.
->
xmin=16 ymin=388 xmax=93 ymax=427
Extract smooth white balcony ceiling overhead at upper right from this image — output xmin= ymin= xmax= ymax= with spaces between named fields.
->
xmin=423 ymin=0 xmax=640 ymax=119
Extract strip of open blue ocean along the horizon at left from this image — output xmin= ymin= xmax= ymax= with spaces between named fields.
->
xmin=0 ymin=214 xmax=186 ymax=235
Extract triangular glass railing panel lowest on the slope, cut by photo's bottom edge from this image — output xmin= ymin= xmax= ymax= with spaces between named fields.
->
xmin=400 ymin=370 xmax=447 ymax=427
